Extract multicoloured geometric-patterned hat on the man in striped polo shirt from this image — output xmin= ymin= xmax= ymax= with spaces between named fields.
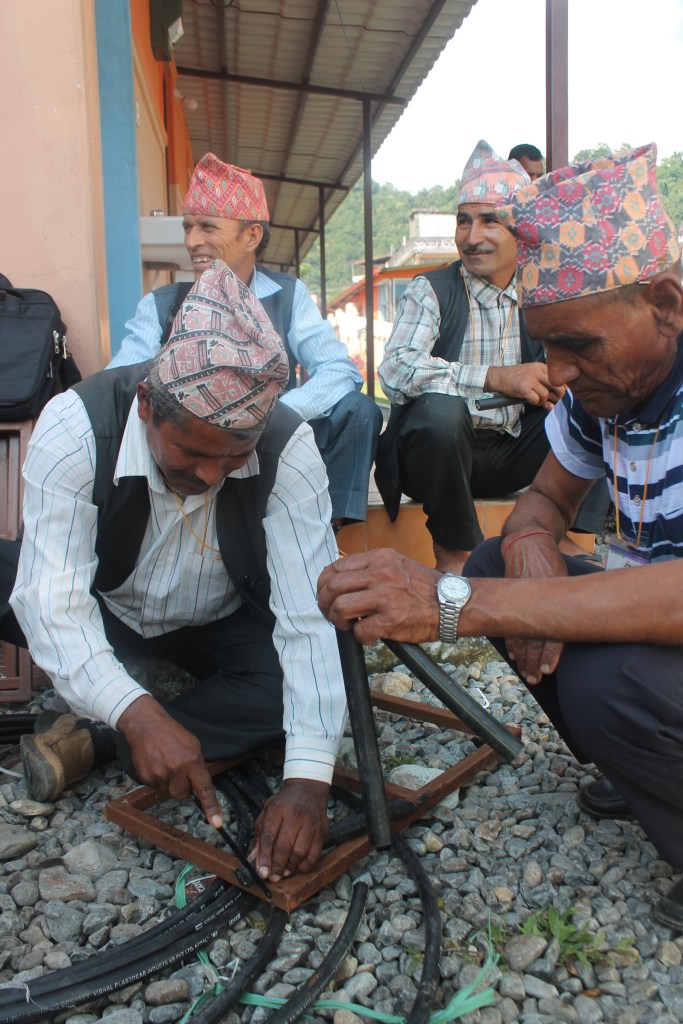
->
xmin=498 ymin=142 xmax=681 ymax=306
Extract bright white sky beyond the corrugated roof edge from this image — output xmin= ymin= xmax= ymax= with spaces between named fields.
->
xmin=372 ymin=0 xmax=683 ymax=193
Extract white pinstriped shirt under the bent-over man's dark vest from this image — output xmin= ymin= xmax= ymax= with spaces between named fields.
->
xmin=11 ymin=391 xmax=346 ymax=781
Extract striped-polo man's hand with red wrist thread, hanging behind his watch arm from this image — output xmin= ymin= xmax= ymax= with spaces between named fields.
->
xmin=503 ymin=534 xmax=568 ymax=686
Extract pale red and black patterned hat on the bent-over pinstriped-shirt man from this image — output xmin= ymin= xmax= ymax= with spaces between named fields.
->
xmin=159 ymin=260 xmax=289 ymax=430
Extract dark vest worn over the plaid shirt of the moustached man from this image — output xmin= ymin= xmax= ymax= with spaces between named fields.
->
xmin=375 ymin=260 xmax=545 ymax=522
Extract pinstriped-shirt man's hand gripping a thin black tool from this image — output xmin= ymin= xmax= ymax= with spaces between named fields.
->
xmin=117 ymin=695 xmax=223 ymax=828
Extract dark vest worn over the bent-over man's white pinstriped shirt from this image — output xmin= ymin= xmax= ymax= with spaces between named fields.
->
xmin=74 ymin=361 xmax=302 ymax=626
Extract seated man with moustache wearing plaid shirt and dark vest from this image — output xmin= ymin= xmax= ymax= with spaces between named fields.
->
xmin=375 ymin=139 xmax=605 ymax=573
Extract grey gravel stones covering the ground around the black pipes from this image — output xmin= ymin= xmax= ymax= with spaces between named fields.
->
xmin=0 ymin=655 xmax=683 ymax=1024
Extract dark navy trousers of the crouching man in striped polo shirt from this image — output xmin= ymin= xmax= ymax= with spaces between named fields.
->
xmin=464 ymin=538 xmax=683 ymax=868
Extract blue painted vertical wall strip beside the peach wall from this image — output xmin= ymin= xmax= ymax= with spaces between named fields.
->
xmin=95 ymin=0 xmax=142 ymax=354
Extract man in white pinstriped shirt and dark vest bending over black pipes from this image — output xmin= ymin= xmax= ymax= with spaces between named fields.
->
xmin=10 ymin=261 xmax=345 ymax=881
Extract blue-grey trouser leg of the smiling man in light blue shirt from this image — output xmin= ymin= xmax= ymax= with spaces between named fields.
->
xmin=309 ymin=391 xmax=382 ymax=522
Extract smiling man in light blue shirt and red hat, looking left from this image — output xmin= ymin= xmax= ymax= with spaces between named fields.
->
xmin=110 ymin=153 xmax=382 ymax=528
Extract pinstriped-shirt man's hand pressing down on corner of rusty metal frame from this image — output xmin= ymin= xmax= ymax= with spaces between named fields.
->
xmin=249 ymin=778 xmax=330 ymax=882
